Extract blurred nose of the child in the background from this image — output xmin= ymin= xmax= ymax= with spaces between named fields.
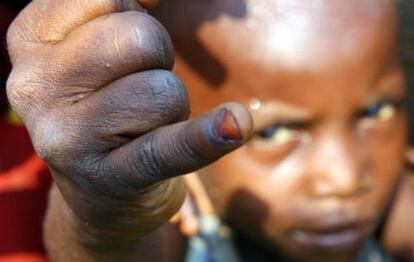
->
xmin=305 ymin=130 xmax=372 ymax=198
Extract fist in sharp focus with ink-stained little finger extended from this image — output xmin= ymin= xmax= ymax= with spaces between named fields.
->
xmin=7 ymin=0 xmax=252 ymax=242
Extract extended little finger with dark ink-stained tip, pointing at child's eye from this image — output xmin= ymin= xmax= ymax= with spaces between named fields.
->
xmin=103 ymin=103 xmax=253 ymax=189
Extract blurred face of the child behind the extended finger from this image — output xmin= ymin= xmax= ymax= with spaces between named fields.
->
xmin=157 ymin=0 xmax=406 ymax=261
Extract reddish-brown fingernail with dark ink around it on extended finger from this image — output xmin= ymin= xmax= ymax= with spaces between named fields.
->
xmin=213 ymin=108 xmax=243 ymax=143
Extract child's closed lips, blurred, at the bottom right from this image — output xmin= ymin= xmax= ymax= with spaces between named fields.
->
xmin=290 ymin=221 xmax=375 ymax=252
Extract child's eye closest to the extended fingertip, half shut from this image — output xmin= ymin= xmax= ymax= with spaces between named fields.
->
xmin=257 ymin=125 xmax=298 ymax=145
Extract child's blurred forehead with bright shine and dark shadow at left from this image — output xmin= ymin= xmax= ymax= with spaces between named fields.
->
xmin=154 ymin=0 xmax=397 ymax=112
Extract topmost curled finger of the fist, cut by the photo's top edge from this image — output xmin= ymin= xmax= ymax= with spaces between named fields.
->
xmin=8 ymin=0 xmax=144 ymax=56
